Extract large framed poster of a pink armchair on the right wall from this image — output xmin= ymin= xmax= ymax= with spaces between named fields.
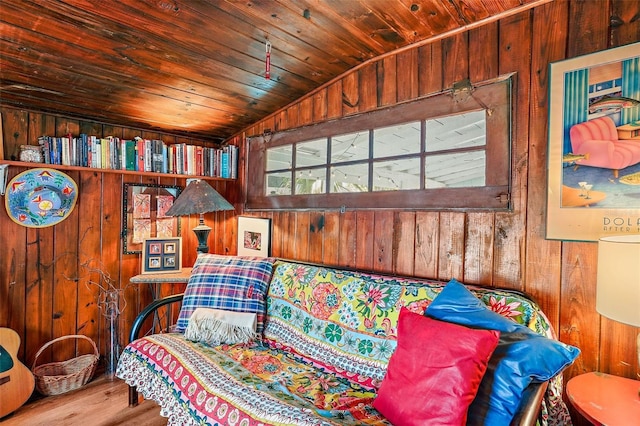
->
xmin=546 ymin=43 xmax=640 ymax=241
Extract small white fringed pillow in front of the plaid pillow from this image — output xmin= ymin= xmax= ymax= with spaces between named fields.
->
xmin=184 ymin=308 xmax=258 ymax=346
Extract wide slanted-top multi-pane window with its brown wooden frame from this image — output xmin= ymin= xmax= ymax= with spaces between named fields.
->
xmin=247 ymin=79 xmax=511 ymax=209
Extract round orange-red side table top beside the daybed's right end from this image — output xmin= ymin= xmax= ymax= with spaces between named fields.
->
xmin=567 ymin=372 xmax=640 ymax=426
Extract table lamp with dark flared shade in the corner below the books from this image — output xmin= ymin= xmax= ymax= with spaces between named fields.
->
xmin=166 ymin=179 xmax=233 ymax=253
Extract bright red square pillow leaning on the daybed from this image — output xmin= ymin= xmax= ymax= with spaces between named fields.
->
xmin=373 ymin=307 xmax=499 ymax=426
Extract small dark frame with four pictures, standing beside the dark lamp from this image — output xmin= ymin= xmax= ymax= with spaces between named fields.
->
xmin=142 ymin=237 xmax=182 ymax=274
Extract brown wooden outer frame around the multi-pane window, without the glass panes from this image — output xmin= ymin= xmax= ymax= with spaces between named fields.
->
xmin=245 ymin=76 xmax=513 ymax=211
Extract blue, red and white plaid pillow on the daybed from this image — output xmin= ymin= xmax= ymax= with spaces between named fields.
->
xmin=176 ymin=254 xmax=273 ymax=335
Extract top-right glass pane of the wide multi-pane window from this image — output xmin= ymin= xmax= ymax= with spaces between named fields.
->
xmin=426 ymin=110 xmax=487 ymax=152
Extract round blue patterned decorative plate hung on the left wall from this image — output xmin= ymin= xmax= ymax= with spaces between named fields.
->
xmin=5 ymin=169 xmax=78 ymax=228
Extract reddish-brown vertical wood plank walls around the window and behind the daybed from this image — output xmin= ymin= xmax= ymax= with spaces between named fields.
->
xmin=0 ymin=0 xmax=640 ymax=422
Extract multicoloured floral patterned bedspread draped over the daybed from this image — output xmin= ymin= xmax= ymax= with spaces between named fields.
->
xmin=117 ymin=261 xmax=571 ymax=426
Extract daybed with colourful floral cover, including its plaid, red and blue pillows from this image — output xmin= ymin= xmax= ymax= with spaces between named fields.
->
xmin=116 ymin=255 xmax=579 ymax=426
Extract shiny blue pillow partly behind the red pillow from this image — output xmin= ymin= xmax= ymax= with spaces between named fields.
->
xmin=425 ymin=280 xmax=580 ymax=425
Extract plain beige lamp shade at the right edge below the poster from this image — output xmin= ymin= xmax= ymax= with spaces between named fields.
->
xmin=596 ymin=235 xmax=640 ymax=327
